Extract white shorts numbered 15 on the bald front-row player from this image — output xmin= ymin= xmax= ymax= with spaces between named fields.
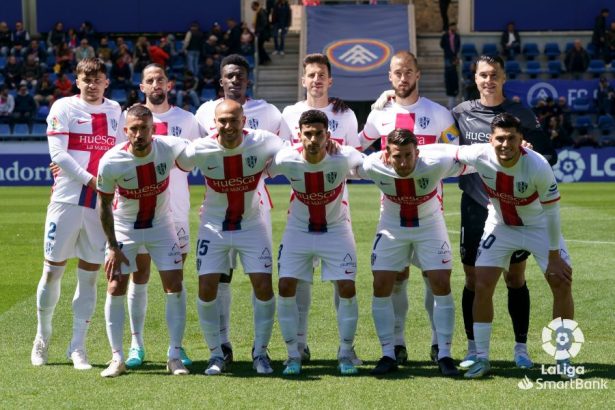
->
xmin=196 ymin=218 xmax=273 ymax=275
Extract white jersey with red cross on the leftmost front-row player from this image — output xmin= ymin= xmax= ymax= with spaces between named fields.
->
xmin=97 ymin=138 xmax=188 ymax=229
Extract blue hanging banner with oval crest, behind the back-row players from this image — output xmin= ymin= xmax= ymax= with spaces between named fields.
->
xmin=305 ymin=5 xmax=410 ymax=101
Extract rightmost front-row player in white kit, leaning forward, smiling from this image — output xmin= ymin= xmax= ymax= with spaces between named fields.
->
xmin=457 ymin=112 xmax=574 ymax=378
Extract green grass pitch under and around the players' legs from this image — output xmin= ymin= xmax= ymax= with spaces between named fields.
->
xmin=0 ymin=183 xmax=615 ymax=409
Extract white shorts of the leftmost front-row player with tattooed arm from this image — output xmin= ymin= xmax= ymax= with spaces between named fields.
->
xmin=110 ymin=225 xmax=183 ymax=274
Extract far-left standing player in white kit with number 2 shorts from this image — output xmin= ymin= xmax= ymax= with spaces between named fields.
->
xmin=31 ymin=58 xmax=121 ymax=370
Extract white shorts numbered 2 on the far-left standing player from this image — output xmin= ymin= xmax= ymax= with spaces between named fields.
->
xmin=43 ymin=202 xmax=107 ymax=264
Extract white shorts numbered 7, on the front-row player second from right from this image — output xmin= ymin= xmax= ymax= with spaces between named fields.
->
xmin=372 ymin=220 xmax=453 ymax=272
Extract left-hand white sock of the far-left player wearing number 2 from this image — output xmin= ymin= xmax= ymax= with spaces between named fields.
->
xmin=36 ymin=262 xmax=66 ymax=341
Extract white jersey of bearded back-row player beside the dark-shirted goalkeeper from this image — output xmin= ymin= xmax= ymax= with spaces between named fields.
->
xmin=359 ymin=97 xmax=459 ymax=149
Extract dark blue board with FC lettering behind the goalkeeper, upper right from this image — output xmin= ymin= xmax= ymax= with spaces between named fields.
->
xmin=504 ymin=80 xmax=615 ymax=107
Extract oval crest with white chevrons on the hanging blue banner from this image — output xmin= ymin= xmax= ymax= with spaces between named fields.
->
xmin=324 ymin=38 xmax=393 ymax=72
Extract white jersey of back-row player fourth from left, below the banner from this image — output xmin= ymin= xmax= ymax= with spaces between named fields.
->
xmin=280 ymin=101 xmax=361 ymax=149
